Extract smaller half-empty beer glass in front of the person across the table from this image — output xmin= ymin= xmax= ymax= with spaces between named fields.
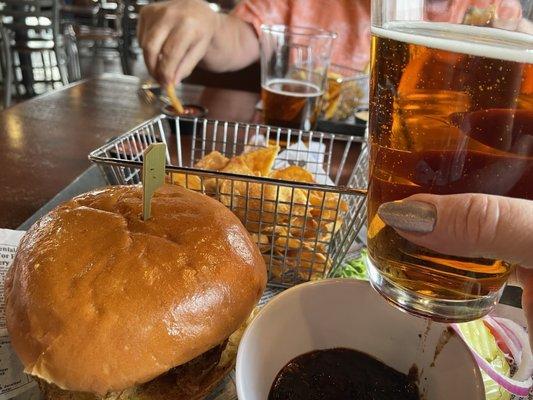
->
xmin=260 ymin=25 xmax=336 ymax=130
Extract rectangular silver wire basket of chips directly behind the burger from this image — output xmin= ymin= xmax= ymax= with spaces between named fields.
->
xmin=89 ymin=115 xmax=368 ymax=287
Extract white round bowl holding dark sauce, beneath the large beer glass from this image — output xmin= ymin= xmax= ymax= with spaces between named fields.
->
xmin=236 ymin=279 xmax=485 ymax=400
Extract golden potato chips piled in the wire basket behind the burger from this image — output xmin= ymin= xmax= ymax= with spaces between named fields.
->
xmin=168 ymin=146 xmax=348 ymax=282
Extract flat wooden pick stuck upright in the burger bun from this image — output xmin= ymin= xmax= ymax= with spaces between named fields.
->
xmin=142 ymin=143 xmax=167 ymax=221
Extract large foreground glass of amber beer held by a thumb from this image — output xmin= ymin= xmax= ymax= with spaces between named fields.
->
xmin=368 ymin=0 xmax=533 ymax=322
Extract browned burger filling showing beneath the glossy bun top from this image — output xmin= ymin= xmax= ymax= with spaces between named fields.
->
xmin=38 ymin=340 xmax=230 ymax=400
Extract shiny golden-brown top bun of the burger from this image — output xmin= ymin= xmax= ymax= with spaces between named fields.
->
xmin=6 ymin=186 xmax=266 ymax=395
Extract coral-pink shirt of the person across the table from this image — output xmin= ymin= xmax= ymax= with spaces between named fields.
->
xmin=232 ymin=0 xmax=370 ymax=70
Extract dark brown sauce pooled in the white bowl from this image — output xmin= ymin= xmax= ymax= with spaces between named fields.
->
xmin=268 ymin=348 xmax=420 ymax=400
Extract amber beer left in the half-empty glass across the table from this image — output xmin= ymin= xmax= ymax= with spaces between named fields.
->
xmin=261 ymin=79 xmax=323 ymax=130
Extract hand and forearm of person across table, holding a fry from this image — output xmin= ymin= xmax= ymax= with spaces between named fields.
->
xmin=138 ymin=0 xmax=259 ymax=84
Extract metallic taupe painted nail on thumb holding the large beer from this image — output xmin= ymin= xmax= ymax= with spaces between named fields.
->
xmin=378 ymin=200 xmax=437 ymax=233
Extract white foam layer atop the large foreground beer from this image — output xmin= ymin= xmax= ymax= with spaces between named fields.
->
xmin=372 ymin=21 xmax=533 ymax=64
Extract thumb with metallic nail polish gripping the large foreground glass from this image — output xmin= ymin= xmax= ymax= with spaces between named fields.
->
xmin=378 ymin=193 xmax=533 ymax=266
